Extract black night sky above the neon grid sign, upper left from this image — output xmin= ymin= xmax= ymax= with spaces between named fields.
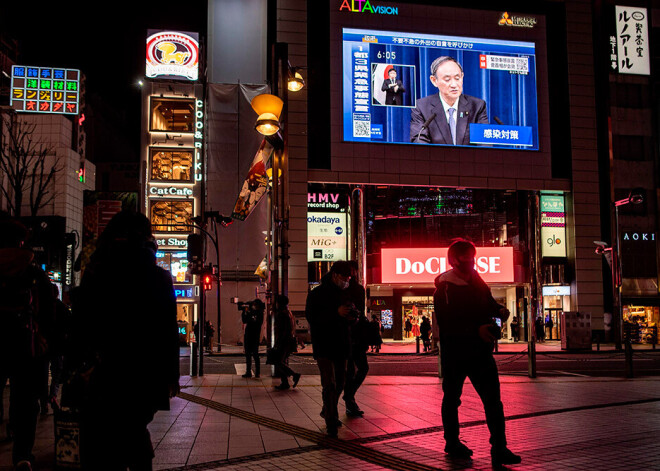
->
xmin=0 ymin=0 xmax=207 ymax=160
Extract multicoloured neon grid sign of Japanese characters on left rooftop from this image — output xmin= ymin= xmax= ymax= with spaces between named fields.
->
xmin=11 ymin=65 xmax=80 ymax=115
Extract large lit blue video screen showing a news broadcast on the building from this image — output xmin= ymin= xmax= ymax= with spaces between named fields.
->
xmin=342 ymin=28 xmax=539 ymax=150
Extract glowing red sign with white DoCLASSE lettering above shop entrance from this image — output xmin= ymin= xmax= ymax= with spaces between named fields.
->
xmin=380 ymin=247 xmax=514 ymax=283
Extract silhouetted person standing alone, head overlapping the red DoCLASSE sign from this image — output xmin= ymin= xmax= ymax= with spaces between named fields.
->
xmin=433 ymin=239 xmax=521 ymax=467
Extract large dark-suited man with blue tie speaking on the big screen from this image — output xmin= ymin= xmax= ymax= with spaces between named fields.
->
xmin=410 ymin=56 xmax=488 ymax=146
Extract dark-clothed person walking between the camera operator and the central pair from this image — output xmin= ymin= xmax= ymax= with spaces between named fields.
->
xmin=274 ymin=295 xmax=300 ymax=391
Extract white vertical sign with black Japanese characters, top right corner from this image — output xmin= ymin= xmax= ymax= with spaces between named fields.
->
xmin=611 ymin=5 xmax=651 ymax=75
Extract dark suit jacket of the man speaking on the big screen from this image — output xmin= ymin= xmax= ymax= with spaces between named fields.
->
xmin=410 ymin=93 xmax=488 ymax=146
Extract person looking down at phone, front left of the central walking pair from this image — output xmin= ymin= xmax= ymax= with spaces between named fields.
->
xmin=305 ymin=261 xmax=357 ymax=437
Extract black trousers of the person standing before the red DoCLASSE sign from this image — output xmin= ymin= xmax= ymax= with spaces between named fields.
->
xmin=441 ymin=348 xmax=506 ymax=448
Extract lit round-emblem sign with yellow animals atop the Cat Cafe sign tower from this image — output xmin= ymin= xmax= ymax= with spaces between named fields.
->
xmin=146 ymin=31 xmax=199 ymax=80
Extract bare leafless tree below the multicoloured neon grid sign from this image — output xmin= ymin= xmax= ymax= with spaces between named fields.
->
xmin=0 ymin=113 xmax=62 ymax=217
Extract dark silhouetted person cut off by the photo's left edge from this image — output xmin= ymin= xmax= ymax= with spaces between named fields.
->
xmin=0 ymin=212 xmax=55 ymax=471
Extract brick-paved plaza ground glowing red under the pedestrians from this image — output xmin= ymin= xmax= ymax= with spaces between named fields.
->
xmin=0 ymin=375 xmax=660 ymax=471
